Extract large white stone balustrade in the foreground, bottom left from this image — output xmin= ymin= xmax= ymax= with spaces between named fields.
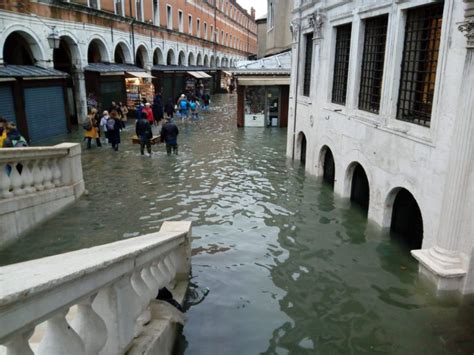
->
xmin=0 ymin=222 xmax=191 ymax=355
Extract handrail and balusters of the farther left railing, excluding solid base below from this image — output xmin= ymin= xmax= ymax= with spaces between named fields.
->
xmin=0 ymin=143 xmax=82 ymax=201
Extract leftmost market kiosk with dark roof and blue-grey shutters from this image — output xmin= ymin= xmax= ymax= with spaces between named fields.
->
xmin=0 ymin=65 xmax=71 ymax=143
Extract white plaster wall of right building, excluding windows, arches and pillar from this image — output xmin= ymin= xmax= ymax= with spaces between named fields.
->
xmin=287 ymin=0 xmax=473 ymax=254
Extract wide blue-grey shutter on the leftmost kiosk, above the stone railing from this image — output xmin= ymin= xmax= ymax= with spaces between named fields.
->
xmin=25 ymin=86 xmax=67 ymax=141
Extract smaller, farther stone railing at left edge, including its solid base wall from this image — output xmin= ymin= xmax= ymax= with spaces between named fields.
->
xmin=0 ymin=143 xmax=84 ymax=245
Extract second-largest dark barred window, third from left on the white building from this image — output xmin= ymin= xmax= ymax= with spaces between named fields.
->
xmin=359 ymin=16 xmax=388 ymax=113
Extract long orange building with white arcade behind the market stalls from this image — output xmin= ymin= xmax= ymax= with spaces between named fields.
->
xmin=0 ymin=0 xmax=257 ymax=142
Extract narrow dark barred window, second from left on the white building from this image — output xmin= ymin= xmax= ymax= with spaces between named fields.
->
xmin=332 ymin=24 xmax=352 ymax=105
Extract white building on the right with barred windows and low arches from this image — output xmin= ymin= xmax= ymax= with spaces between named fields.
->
xmin=287 ymin=0 xmax=474 ymax=294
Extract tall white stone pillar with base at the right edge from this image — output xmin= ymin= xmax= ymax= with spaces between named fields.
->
xmin=412 ymin=20 xmax=474 ymax=291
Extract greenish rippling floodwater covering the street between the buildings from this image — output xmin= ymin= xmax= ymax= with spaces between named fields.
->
xmin=0 ymin=96 xmax=474 ymax=355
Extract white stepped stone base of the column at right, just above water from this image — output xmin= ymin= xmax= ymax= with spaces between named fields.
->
xmin=411 ymin=247 xmax=467 ymax=291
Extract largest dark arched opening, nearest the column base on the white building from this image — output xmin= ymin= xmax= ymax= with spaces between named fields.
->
xmin=390 ymin=188 xmax=423 ymax=249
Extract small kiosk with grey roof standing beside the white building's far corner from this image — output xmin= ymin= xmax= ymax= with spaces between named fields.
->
xmin=234 ymin=52 xmax=291 ymax=127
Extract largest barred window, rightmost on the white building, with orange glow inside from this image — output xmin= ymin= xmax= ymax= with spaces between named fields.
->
xmin=397 ymin=4 xmax=443 ymax=127
